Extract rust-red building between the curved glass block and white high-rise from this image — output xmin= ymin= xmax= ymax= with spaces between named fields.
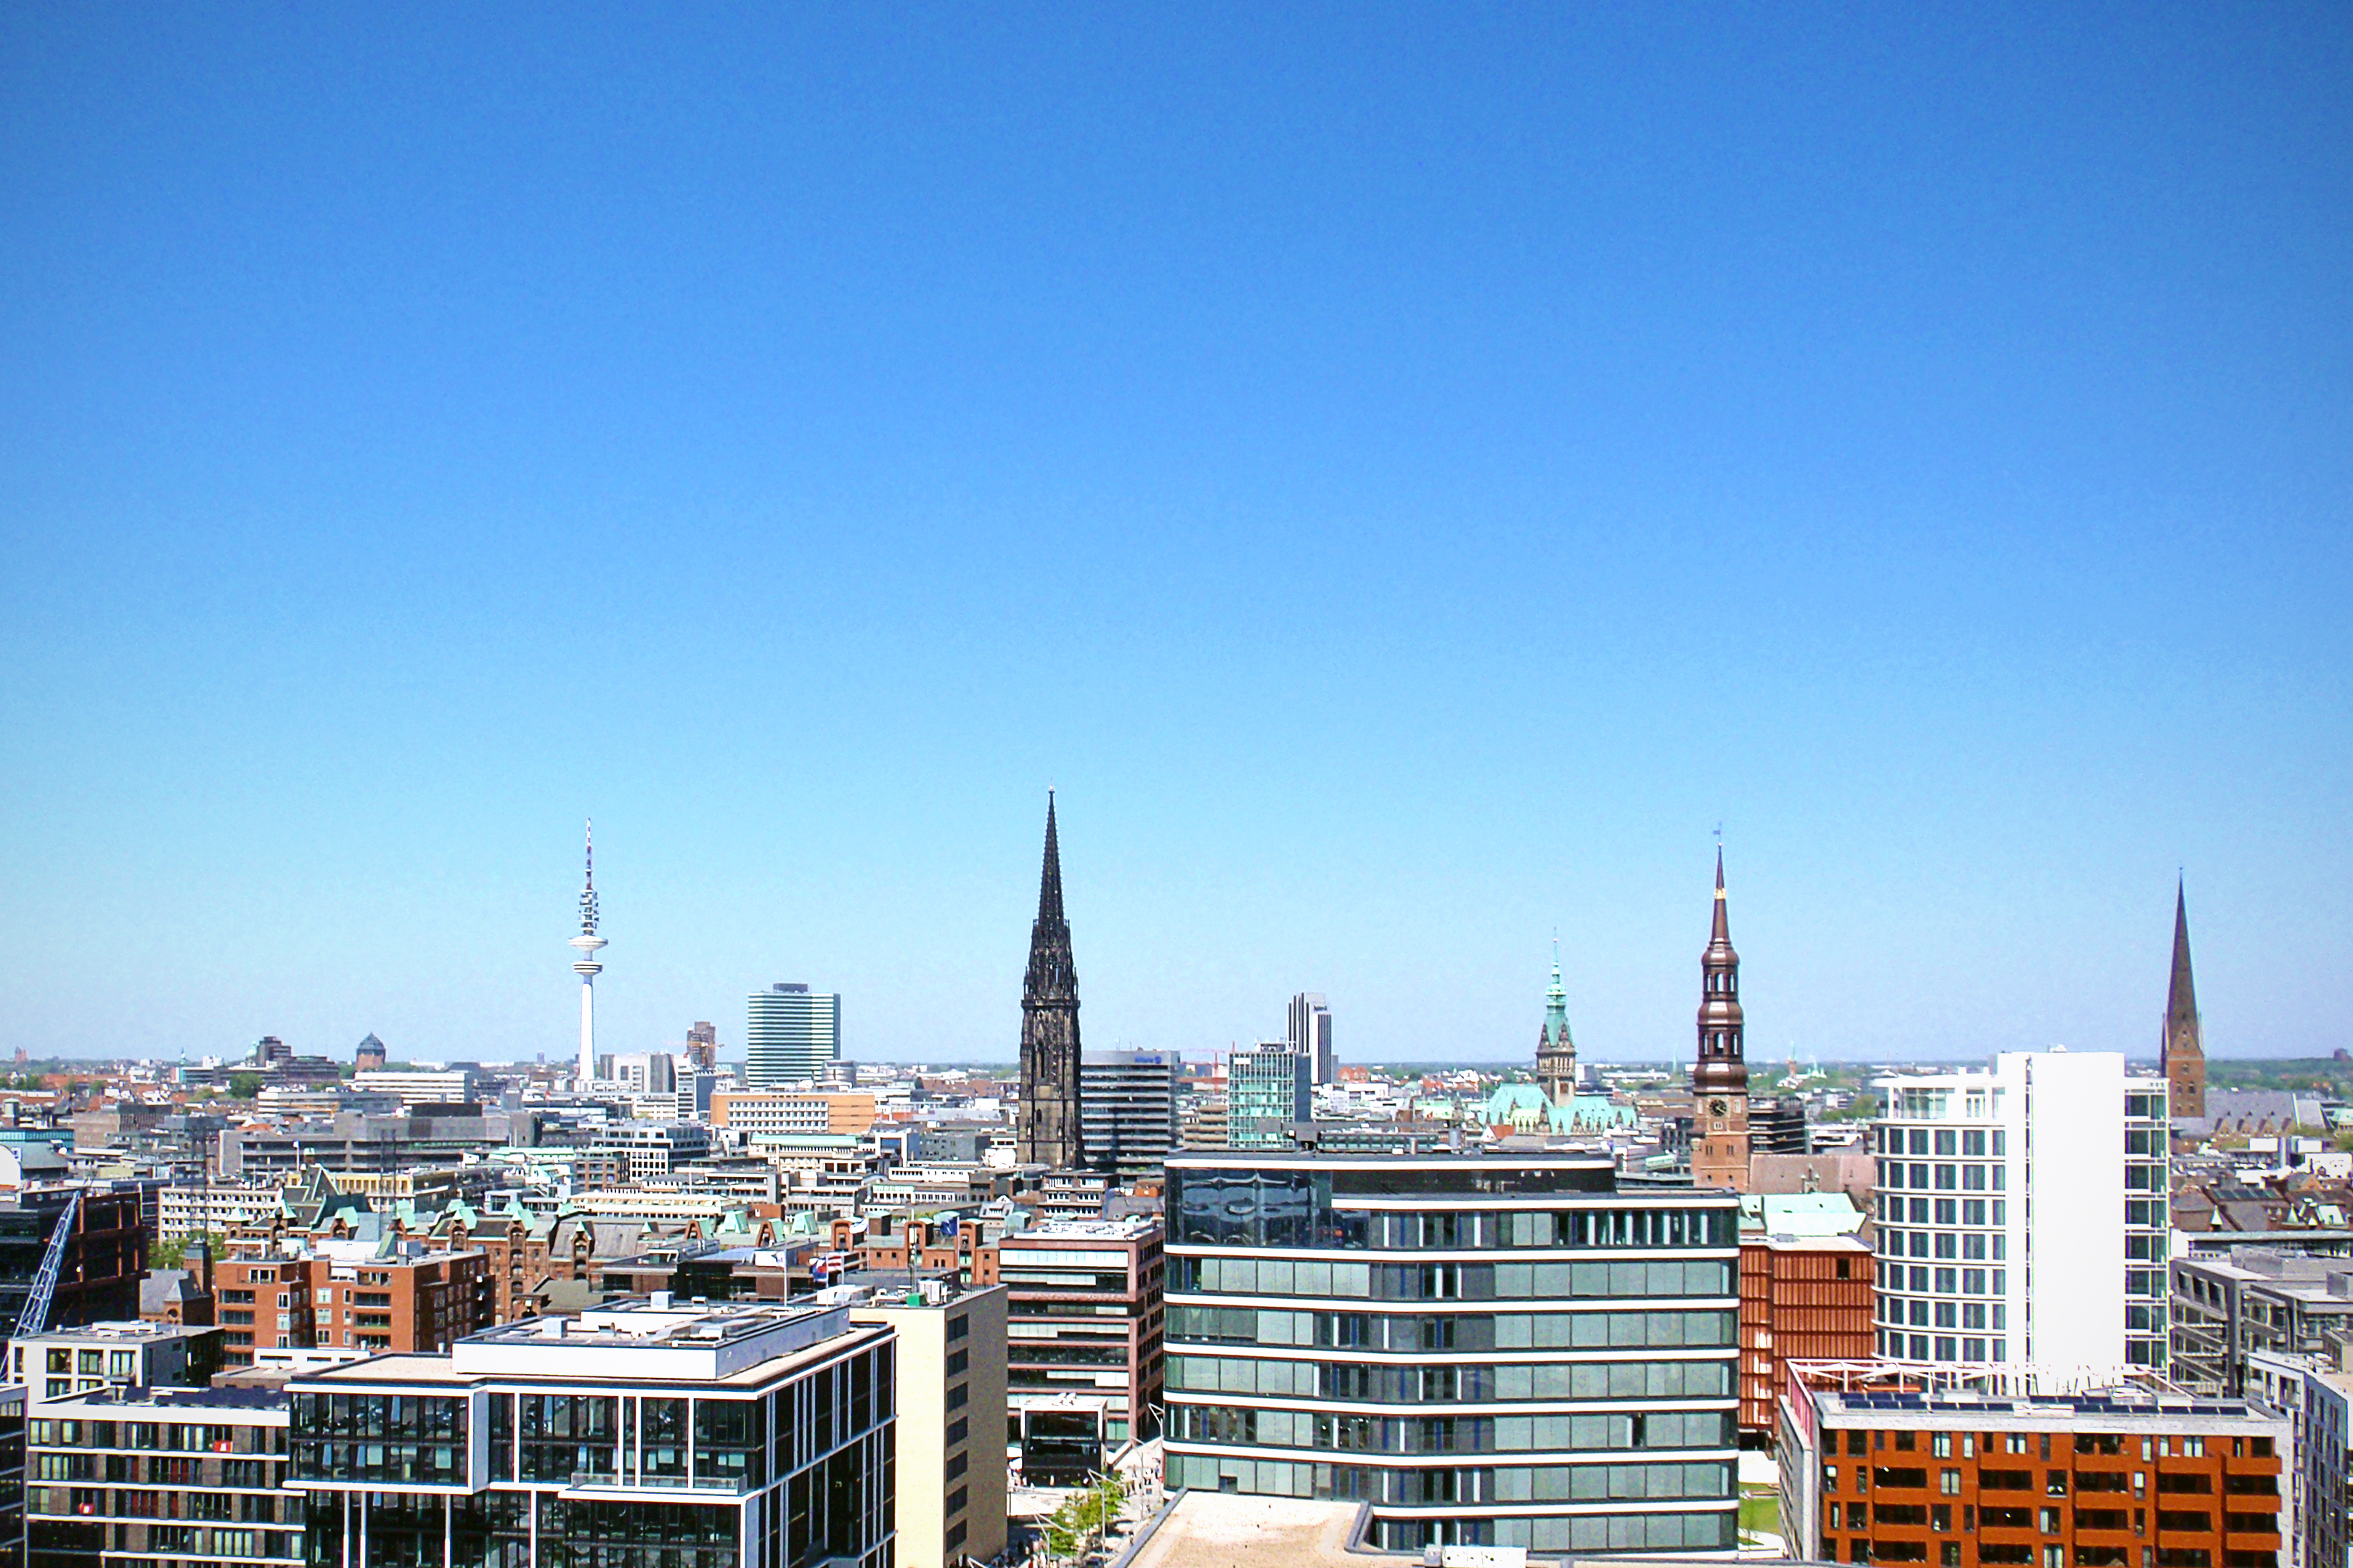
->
xmin=1741 ymin=1234 xmax=1875 ymax=1448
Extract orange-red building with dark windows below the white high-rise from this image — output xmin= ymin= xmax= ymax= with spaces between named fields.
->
xmin=1781 ymin=1363 xmax=2289 ymax=1568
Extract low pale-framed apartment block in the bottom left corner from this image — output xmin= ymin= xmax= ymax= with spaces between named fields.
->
xmin=28 ymin=1387 xmax=303 ymax=1568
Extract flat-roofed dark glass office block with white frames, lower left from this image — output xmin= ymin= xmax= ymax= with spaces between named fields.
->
xmin=287 ymin=1293 xmax=899 ymax=1568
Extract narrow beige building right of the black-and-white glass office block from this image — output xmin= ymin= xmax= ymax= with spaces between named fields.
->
xmin=849 ymin=1276 xmax=1004 ymax=1568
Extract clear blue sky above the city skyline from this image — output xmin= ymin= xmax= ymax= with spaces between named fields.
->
xmin=0 ymin=4 xmax=2353 ymax=1060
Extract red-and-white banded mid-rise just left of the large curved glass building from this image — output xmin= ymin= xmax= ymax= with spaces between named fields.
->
xmin=998 ymin=1218 xmax=1165 ymax=1486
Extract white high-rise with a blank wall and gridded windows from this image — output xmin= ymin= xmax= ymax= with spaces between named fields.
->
xmin=1870 ymin=1051 xmax=2167 ymax=1368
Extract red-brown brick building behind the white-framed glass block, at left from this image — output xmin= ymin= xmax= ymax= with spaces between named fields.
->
xmin=214 ymin=1251 xmax=496 ymax=1366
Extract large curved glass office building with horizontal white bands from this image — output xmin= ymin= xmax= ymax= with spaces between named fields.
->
xmin=1165 ymin=1154 xmax=1739 ymax=1554
